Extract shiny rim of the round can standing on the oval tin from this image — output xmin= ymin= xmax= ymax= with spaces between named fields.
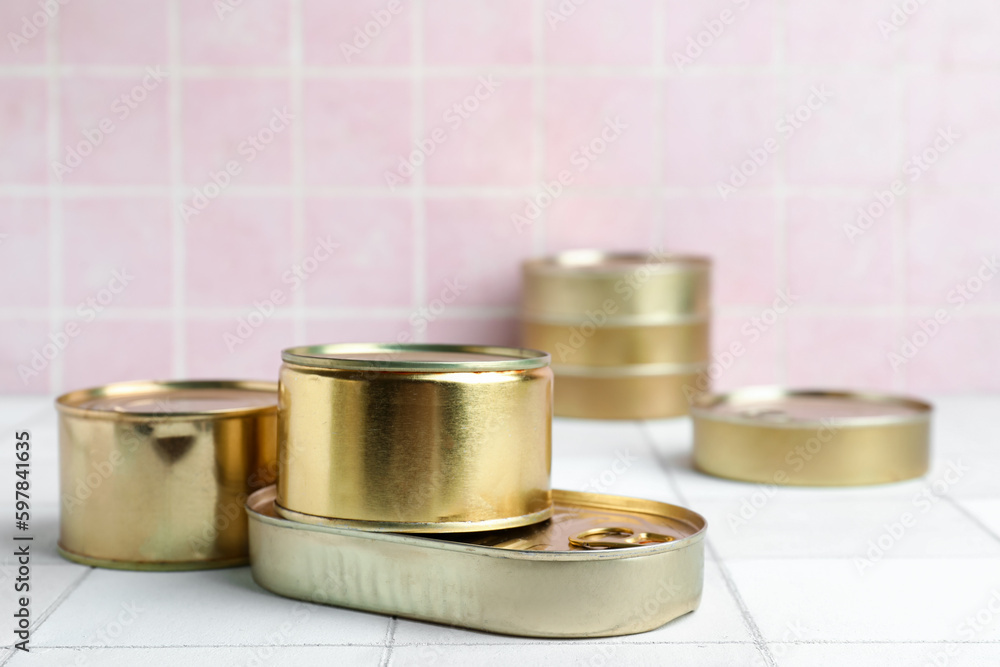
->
xmin=281 ymin=343 xmax=551 ymax=372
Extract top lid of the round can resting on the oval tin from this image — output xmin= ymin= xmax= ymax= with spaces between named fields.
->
xmin=281 ymin=343 xmax=550 ymax=372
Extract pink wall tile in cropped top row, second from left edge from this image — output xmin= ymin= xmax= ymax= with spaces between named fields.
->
xmin=59 ymin=0 xmax=169 ymax=65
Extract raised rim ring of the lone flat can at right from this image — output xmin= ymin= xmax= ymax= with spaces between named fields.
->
xmin=691 ymin=386 xmax=934 ymax=429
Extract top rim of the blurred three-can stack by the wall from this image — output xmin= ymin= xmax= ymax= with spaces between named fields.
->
xmin=524 ymin=248 xmax=712 ymax=275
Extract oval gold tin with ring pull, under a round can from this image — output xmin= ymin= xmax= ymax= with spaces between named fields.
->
xmin=247 ymin=489 xmax=705 ymax=637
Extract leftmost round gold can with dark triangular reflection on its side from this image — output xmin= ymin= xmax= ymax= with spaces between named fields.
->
xmin=56 ymin=381 xmax=278 ymax=570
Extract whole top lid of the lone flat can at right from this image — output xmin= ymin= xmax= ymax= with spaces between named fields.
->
xmin=691 ymin=387 xmax=932 ymax=428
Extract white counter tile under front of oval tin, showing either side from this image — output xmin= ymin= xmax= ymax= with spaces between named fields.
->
xmin=395 ymin=562 xmax=751 ymax=645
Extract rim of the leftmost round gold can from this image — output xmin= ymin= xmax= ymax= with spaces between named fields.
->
xmin=55 ymin=380 xmax=278 ymax=420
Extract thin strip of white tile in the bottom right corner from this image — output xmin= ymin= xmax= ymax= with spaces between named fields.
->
xmin=768 ymin=643 xmax=1000 ymax=667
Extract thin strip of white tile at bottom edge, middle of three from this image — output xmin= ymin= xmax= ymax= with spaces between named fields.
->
xmin=390 ymin=643 xmax=758 ymax=667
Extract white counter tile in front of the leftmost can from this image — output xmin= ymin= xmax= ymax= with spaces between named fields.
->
xmin=35 ymin=567 xmax=388 ymax=646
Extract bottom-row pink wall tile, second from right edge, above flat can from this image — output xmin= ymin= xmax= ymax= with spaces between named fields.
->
xmin=787 ymin=313 xmax=897 ymax=390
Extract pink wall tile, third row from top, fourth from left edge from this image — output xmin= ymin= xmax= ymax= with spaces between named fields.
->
xmin=302 ymin=198 xmax=413 ymax=307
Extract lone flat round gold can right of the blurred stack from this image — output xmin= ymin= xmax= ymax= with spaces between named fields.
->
xmin=691 ymin=387 xmax=932 ymax=486
